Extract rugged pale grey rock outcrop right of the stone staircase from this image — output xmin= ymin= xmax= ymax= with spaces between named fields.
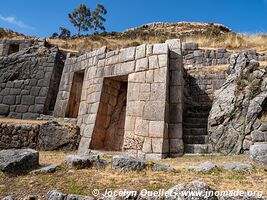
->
xmin=208 ymin=53 xmax=267 ymax=154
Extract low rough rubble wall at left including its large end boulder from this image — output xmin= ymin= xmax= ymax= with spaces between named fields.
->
xmin=0 ymin=120 xmax=80 ymax=151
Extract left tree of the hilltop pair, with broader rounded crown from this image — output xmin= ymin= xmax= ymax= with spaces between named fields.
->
xmin=68 ymin=4 xmax=92 ymax=35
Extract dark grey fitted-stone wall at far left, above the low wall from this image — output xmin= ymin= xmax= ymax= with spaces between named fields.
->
xmin=0 ymin=40 xmax=63 ymax=119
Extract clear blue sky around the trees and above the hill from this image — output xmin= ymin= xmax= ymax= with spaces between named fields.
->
xmin=0 ymin=0 xmax=267 ymax=37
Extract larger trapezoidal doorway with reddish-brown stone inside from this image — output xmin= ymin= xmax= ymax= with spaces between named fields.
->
xmin=90 ymin=76 xmax=128 ymax=151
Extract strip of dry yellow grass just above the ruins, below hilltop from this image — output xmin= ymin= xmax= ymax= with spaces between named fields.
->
xmin=48 ymin=33 xmax=267 ymax=53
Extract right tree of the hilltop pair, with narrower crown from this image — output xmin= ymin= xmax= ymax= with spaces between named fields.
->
xmin=91 ymin=4 xmax=107 ymax=33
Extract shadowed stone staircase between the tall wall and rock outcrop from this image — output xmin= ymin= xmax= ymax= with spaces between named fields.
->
xmin=183 ymin=105 xmax=211 ymax=154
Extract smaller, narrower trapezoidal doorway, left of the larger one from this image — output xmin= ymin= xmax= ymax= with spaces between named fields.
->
xmin=65 ymin=71 xmax=84 ymax=118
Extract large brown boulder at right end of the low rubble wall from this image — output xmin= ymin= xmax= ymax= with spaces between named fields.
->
xmin=38 ymin=121 xmax=80 ymax=151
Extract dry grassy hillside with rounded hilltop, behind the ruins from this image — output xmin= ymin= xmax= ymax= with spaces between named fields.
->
xmin=0 ymin=22 xmax=267 ymax=53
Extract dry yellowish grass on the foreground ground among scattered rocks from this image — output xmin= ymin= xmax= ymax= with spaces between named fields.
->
xmin=0 ymin=152 xmax=267 ymax=199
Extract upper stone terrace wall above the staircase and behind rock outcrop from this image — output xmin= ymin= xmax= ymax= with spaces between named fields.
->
xmin=182 ymin=43 xmax=267 ymax=69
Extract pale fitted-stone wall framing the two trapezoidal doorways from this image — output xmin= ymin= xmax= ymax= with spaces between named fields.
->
xmin=54 ymin=40 xmax=183 ymax=159
